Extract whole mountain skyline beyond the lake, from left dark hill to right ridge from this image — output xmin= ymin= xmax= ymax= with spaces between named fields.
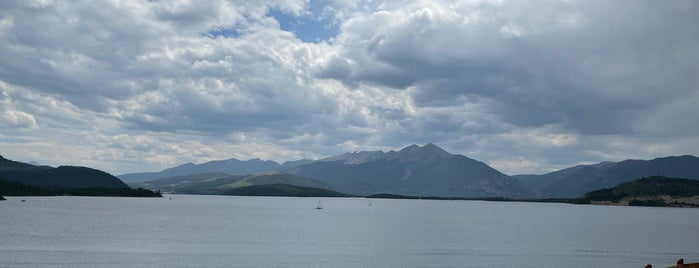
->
xmin=0 ymin=143 xmax=699 ymax=199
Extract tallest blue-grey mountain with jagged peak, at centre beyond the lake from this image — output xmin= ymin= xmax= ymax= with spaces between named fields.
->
xmin=287 ymin=143 xmax=526 ymax=197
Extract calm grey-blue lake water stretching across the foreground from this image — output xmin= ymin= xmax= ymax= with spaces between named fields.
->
xmin=0 ymin=195 xmax=699 ymax=267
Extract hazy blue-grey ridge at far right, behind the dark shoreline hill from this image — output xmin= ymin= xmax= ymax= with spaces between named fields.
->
xmin=513 ymin=155 xmax=699 ymax=197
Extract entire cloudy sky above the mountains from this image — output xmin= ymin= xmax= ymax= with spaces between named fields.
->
xmin=0 ymin=0 xmax=699 ymax=175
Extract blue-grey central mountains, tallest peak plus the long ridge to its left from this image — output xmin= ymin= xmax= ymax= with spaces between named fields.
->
xmin=126 ymin=143 xmax=527 ymax=198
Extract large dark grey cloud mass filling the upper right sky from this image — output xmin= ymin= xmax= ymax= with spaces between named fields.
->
xmin=320 ymin=1 xmax=699 ymax=135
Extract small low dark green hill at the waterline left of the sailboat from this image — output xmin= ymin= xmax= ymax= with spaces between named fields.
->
xmin=222 ymin=183 xmax=349 ymax=197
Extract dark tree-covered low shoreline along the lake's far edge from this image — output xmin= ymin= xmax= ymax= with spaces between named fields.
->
xmin=0 ymin=173 xmax=699 ymax=208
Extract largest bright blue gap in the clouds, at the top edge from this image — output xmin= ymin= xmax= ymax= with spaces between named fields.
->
xmin=267 ymin=0 xmax=338 ymax=43
